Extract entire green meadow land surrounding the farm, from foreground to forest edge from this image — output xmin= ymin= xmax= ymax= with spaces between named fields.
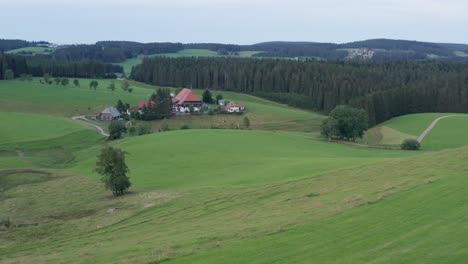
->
xmin=0 ymin=79 xmax=468 ymax=264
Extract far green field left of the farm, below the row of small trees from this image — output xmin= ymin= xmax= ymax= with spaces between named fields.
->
xmin=0 ymin=78 xmax=153 ymax=117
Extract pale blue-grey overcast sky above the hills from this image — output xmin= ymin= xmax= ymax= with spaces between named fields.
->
xmin=0 ymin=0 xmax=468 ymax=44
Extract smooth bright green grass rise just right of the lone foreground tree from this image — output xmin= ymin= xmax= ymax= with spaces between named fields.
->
xmin=74 ymin=130 xmax=414 ymax=189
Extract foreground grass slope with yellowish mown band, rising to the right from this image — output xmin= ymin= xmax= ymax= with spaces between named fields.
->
xmin=0 ymin=139 xmax=468 ymax=263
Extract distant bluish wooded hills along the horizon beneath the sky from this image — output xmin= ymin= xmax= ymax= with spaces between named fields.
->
xmin=0 ymin=39 xmax=468 ymax=63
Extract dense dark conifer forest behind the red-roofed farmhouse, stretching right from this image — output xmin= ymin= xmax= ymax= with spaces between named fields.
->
xmin=131 ymin=58 xmax=468 ymax=125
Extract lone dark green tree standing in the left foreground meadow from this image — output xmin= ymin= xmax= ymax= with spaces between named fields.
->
xmin=96 ymin=146 xmax=131 ymax=196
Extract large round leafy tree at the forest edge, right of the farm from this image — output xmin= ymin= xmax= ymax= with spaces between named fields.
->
xmin=322 ymin=105 xmax=369 ymax=141
